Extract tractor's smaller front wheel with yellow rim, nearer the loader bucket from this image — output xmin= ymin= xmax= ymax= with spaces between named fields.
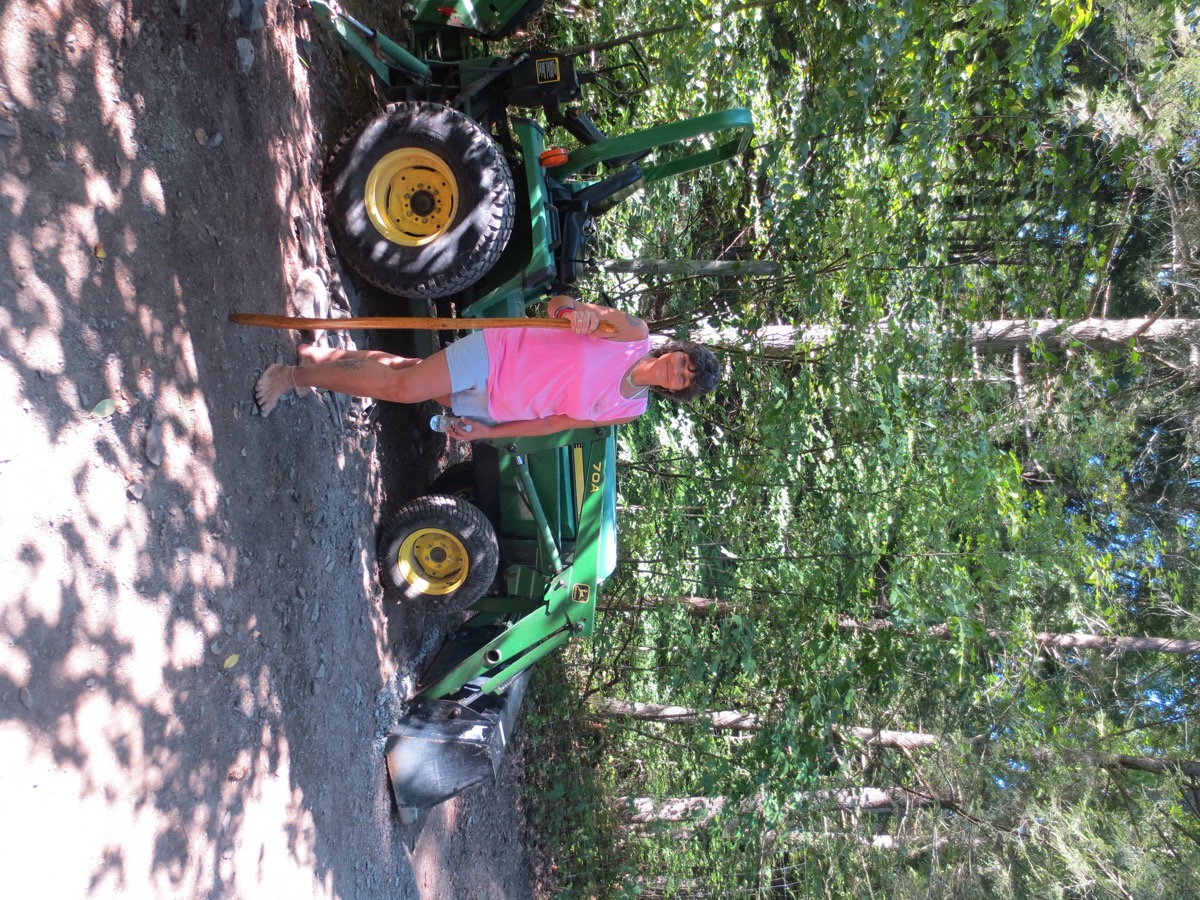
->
xmin=379 ymin=494 xmax=500 ymax=613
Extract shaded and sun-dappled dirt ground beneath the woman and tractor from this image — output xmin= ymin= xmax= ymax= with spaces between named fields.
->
xmin=0 ymin=0 xmax=540 ymax=899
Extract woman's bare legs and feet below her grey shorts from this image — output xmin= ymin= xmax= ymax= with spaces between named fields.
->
xmin=254 ymin=348 xmax=450 ymax=416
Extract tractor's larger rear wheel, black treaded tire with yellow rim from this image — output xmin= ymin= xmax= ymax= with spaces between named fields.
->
xmin=324 ymin=102 xmax=516 ymax=299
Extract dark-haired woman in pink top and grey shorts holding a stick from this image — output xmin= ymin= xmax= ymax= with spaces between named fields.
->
xmin=254 ymin=295 xmax=719 ymax=440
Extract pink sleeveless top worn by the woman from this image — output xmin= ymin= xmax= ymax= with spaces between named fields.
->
xmin=484 ymin=328 xmax=650 ymax=422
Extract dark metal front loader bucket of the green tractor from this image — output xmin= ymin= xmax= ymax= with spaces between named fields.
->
xmin=384 ymin=670 xmax=530 ymax=821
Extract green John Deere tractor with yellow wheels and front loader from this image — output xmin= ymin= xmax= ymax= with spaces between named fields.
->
xmin=311 ymin=0 xmax=752 ymax=817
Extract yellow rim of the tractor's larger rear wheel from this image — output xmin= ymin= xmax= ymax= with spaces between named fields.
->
xmin=364 ymin=148 xmax=458 ymax=247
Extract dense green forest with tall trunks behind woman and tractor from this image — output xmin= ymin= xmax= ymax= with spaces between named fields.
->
xmin=511 ymin=0 xmax=1200 ymax=898
